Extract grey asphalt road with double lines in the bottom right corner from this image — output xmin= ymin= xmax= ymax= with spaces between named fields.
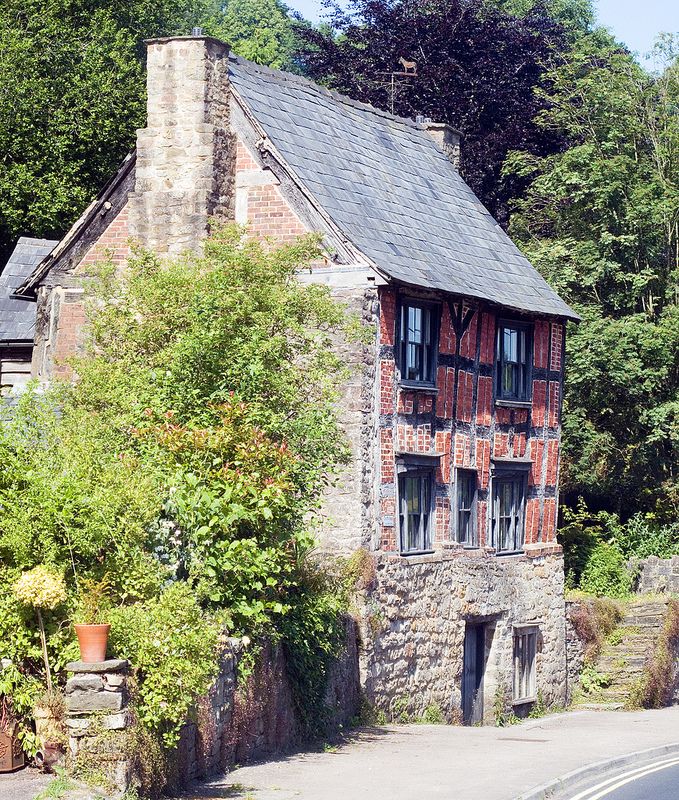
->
xmin=569 ymin=755 xmax=679 ymax=800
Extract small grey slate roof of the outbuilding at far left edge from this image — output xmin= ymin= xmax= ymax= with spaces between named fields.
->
xmin=0 ymin=236 xmax=57 ymax=342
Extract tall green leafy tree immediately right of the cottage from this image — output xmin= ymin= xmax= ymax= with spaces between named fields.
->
xmin=505 ymin=35 xmax=679 ymax=519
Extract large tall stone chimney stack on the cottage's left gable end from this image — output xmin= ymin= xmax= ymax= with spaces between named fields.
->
xmin=130 ymin=36 xmax=235 ymax=255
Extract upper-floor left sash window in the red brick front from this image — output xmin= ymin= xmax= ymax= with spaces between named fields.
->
xmin=399 ymin=302 xmax=438 ymax=386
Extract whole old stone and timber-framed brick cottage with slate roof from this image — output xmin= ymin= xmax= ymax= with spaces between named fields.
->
xmin=13 ymin=36 xmax=576 ymax=724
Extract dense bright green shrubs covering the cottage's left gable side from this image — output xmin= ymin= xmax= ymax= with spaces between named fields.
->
xmin=0 ymin=228 xmax=356 ymax=744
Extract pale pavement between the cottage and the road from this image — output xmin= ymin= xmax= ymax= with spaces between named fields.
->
xmin=184 ymin=707 xmax=679 ymax=800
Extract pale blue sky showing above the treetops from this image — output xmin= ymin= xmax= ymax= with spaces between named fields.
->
xmin=286 ymin=0 xmax=679 ymax=58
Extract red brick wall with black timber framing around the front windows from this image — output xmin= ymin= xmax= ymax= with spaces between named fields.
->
xmin=379 ymin=287 xmax=563 ymax=552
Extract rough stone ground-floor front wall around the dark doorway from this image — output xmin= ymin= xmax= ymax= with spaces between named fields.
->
xmin=361 ymin=548 xmax=566 ymax=723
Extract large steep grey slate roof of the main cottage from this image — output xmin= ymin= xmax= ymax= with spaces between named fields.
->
xmin=230 ymin=55 xmax=578 ymax=319
